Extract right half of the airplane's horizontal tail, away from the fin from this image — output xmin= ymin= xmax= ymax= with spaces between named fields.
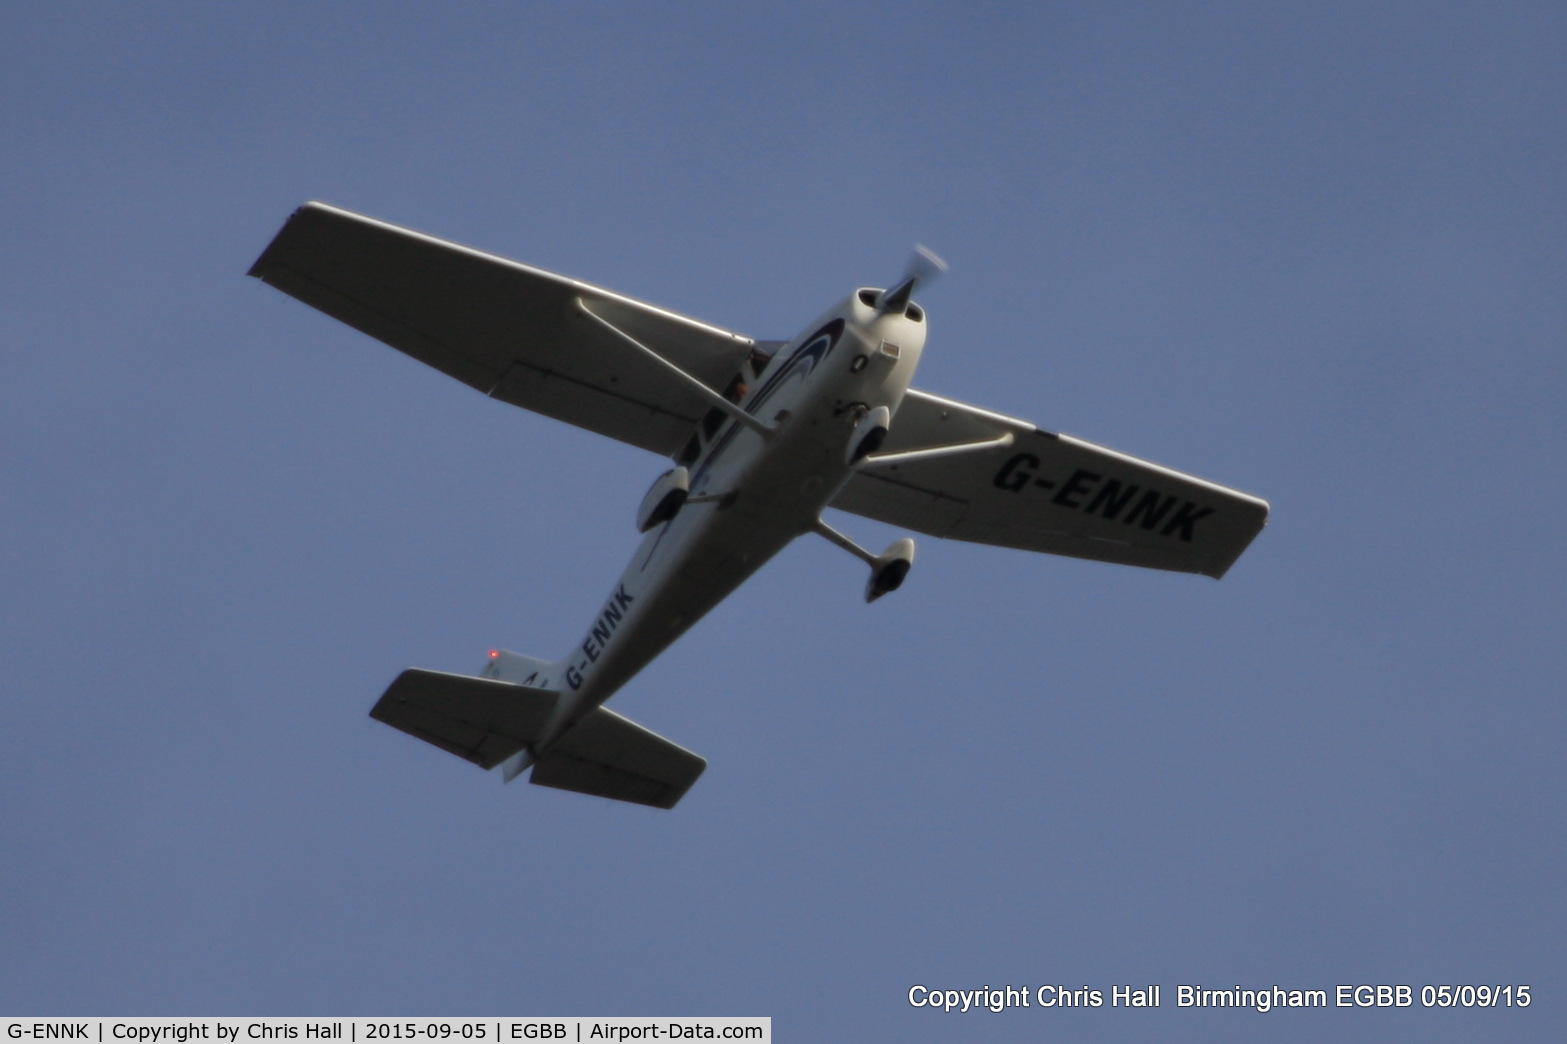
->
xmin=530 ymin=707 xmax=707 ymax=809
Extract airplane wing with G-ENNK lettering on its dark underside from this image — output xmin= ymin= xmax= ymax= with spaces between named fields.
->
xmin=832 ymin=389 xmax=1268 ymax=578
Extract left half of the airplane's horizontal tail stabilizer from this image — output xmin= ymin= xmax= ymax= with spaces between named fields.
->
xmin=370 ymin=669 xmax=558 ymax=768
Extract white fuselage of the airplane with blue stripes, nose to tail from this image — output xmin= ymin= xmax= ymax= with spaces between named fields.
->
xmin=541 ymin=295 xmax=926 ymax=736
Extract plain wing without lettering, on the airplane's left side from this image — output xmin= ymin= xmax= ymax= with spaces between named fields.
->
xmin=249 ymin=202 xmax=755 ymax=456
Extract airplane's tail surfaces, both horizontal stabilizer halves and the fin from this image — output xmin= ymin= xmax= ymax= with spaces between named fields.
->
xmin=370 ymin=654 xmax=707 ymax=809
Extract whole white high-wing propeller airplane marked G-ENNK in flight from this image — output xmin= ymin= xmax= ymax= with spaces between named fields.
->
xmin=249 ymin=202 xmax=1268 ymax=809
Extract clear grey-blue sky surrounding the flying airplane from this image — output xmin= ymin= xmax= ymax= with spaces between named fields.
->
xmin=0 ymin=3 xmax=1567 ymax=1041
